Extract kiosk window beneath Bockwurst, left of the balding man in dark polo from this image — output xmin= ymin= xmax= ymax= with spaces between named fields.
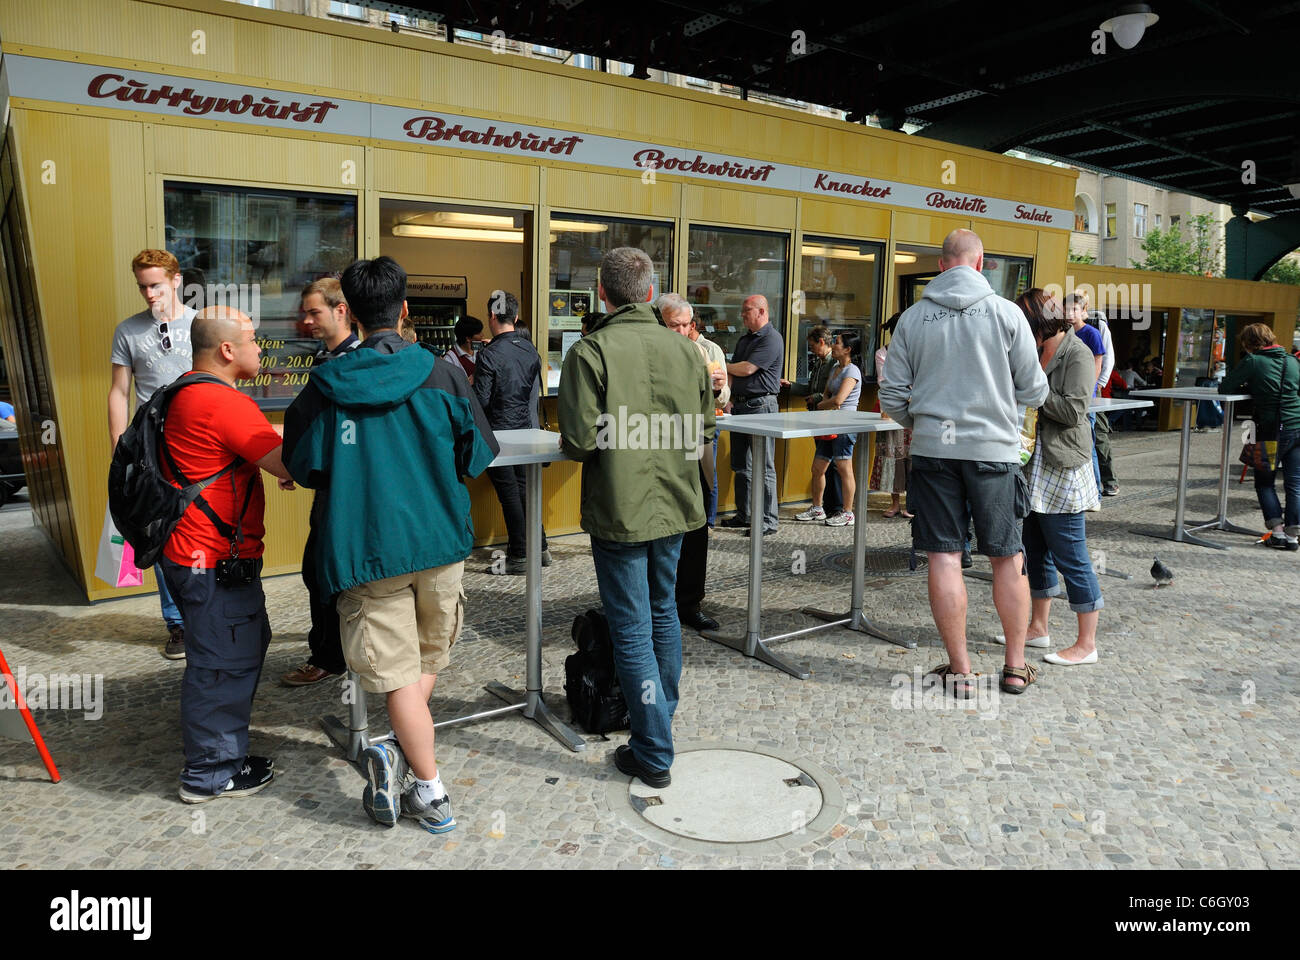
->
xmin=686 ymin=226 xmax=789 ymax=359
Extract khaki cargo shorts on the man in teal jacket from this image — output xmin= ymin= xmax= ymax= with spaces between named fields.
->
xmin=338 ymin=561 xmax=465 ymax=693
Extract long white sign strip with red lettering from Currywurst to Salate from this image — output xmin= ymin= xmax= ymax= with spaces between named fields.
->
xmin=4 ymin=55 xmax=1074 ymax=230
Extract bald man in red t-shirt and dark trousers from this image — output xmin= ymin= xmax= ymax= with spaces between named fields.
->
xmin=163 ymin=307 xmax=293 ymax=804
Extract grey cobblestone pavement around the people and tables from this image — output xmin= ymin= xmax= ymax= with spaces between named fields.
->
xmin=0 ymin=433 xmax=1300 ymax=869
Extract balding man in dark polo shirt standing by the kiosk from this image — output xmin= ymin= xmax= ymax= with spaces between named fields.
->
xmin=722 ymin=294 xmax=785 ymax=533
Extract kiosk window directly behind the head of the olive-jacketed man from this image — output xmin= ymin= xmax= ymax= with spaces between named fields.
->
xmin=542 ymin=212 xmax=672 ymax=394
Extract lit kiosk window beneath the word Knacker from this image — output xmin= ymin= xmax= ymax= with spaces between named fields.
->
xmin=790 ymin=237 xmax=885 ymax=382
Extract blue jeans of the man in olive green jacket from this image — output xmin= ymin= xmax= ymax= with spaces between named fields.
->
xmin=592 ymin=533 xmax=681 ymax=770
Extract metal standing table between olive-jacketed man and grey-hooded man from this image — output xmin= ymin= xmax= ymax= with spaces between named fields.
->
xmin=701 ymin=410 xmax=917 ymax=680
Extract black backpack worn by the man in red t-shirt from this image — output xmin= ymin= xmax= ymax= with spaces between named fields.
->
xmin=108 ymin=373 xmax=246 ymax=570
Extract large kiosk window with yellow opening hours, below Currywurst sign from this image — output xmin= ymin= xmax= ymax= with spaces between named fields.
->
xmin=163 ymin=182 xmax=356 ymax=410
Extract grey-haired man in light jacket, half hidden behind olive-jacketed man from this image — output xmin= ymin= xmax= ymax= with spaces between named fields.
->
xmin=655 ymin=293 xmax=731 ymax=630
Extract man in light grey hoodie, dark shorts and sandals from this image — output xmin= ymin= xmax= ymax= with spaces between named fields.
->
xmin=880 ymin=230 xmax=1048 ymax=697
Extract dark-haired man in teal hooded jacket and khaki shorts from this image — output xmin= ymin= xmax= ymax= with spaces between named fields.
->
xmin=285 ymin=256 xmax=498 ymax=834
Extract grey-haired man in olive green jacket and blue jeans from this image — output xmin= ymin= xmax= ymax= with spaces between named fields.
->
xmin=559 ymin=247 xmax=714 ymax=787
